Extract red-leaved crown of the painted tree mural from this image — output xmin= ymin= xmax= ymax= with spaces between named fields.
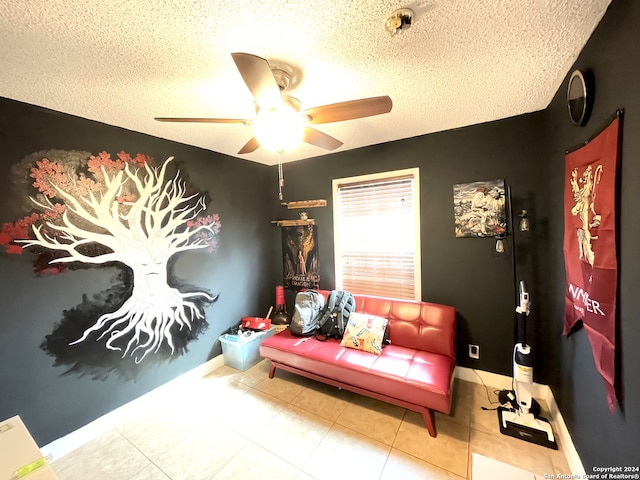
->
xmin=5 ymin=150 xmax=221 ymax=273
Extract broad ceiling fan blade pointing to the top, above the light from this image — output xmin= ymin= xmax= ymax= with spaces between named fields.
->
xmin=231 ymin=53 xmax=282 ymax=108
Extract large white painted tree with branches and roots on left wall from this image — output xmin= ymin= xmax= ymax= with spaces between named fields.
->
xmin=3 ymin=152 xmax=220 ymax=363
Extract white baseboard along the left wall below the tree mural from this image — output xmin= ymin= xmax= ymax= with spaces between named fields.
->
xmin=40 ymin=355 xmax=223 ymax=460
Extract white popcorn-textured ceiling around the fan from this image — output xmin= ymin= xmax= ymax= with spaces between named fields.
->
xmin=0 ymin=0 xmax=611 ymax=165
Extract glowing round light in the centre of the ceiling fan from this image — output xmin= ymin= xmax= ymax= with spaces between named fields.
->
xmin=253 ymin=105 xmax=304 ymax=152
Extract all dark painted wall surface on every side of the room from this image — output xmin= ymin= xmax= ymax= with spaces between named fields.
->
xmin=0 ymin=0 xmax=640 ymax=464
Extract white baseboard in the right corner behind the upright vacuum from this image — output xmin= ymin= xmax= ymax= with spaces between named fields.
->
xmin=455 ymin=366 xmax=586 ymax=472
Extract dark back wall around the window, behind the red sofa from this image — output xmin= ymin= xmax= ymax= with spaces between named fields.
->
xmin=272 ymin=113 xmax=549 ymax=381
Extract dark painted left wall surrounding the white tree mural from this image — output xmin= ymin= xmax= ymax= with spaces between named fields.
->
xmin=0 ymin=98 xmax=274 ymax=445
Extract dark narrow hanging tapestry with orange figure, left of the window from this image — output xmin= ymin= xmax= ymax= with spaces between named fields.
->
xmin=282 ymin=225 xmax=320 ymax=290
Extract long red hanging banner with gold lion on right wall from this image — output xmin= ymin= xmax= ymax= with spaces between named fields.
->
xmin=562 ymin=115 xmax=621 ymax=412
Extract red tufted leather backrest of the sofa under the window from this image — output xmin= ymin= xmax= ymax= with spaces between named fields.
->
xmin=320 ymin=290 xmax=456 ymax=360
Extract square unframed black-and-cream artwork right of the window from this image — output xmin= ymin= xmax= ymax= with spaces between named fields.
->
xmin=453 ymin=180 xmax=507 ymax=238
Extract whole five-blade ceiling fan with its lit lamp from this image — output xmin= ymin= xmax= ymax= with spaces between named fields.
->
xmin=155 ymin=53 xmax=393 ymax=154
